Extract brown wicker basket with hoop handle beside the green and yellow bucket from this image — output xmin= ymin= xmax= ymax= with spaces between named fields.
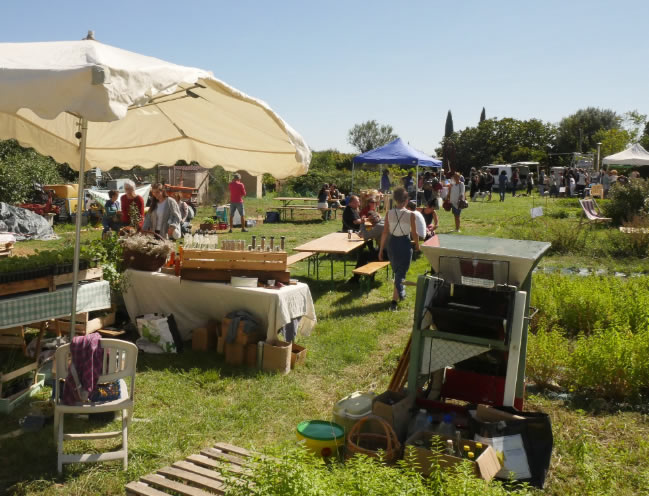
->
xmin=345 ymin=415 xmax=401 ymax=463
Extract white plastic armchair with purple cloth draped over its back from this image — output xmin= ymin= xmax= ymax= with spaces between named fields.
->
xmin=54 ymin=339 xmax=138 ymax=473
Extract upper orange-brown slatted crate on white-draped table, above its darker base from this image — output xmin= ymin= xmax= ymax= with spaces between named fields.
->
xmin=182 ymin=250 xmax=287 ymax=272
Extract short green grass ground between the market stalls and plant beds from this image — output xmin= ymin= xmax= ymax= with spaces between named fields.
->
xmin=0 ymin=196 xmax=649 ymax=496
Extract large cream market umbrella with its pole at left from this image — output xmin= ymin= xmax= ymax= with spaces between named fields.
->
xmin=0 ymin=32 xmax=311 ymax=335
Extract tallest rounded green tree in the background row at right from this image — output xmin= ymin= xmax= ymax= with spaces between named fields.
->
xmin=557 ymin=107 xmax=622 ymax=153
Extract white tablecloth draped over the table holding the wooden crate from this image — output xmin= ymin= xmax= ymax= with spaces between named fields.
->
xmin=124 ymin=270 xmax=316 ymax=340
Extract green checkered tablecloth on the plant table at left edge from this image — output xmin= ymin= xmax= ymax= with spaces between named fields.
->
xmin=0 ymin=281 xmax=110 ymax=329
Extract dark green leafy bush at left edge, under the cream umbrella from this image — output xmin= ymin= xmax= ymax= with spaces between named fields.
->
xmin=0 ymin=140 xmax=71 ymax=203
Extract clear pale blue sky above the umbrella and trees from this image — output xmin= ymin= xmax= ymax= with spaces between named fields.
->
xmin=0 ymin=0 xmax=649 ymax=153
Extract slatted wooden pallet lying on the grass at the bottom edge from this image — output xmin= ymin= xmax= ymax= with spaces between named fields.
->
xmin=125 ymin=443 xmax=251 ymax=496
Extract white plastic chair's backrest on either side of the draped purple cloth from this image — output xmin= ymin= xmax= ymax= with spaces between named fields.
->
xmin=54 ymin=339 xmax=138 ymax=402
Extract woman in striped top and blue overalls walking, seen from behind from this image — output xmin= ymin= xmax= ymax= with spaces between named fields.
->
xmin=379 ymin=187 xmax=419 ymax=312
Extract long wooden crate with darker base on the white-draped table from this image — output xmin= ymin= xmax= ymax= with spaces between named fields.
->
xmin=180 ymin=250 xmax=291 ymax=284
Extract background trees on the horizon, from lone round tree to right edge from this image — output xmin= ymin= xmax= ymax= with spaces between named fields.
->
xmin=348 ymin=107 xmax=649 ymax=177
